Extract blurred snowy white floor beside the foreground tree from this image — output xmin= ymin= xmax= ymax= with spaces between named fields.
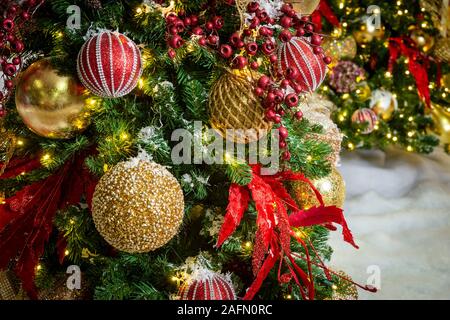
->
xmin=330 ymin=150 xmax=450 ymax=299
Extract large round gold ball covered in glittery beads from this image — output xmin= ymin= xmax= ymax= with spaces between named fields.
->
xmin=92 ymin=158 xmax=184 ymax=253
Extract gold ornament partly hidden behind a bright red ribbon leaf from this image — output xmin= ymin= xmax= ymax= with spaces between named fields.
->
xmin=291 ymin=168 xmax=345 ymax=210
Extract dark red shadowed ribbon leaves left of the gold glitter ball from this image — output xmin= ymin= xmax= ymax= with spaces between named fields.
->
xmin=0 ymin=154 xmax=97 ymax=299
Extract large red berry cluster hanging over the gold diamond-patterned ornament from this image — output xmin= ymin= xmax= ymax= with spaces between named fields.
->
xmin=166 ymin=0 xmax=331 ymax=160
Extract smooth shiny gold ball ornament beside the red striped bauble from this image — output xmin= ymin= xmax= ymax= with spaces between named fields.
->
xmin=16 ymin=58 xmax=90 ymax=139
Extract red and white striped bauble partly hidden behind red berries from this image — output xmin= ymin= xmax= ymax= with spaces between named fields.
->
xmin=278 ymin=37 xmax=327 ymax=92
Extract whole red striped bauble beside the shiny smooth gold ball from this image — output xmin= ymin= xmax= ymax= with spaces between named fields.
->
xmin=77 ymin=31 xmax=142 ymax=98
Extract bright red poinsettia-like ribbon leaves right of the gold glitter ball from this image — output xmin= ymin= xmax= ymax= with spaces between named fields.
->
xmin=216 ymin=166 xmax=357 ymax=300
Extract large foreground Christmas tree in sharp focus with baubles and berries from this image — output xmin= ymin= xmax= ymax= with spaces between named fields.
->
xmin=0 ymin=0 xmax=382 ymax=300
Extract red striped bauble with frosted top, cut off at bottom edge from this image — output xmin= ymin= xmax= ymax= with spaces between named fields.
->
xmin=178 ymin=269 xmax=236 ymax=300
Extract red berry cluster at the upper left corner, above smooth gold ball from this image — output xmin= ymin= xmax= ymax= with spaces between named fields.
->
xmin=0 ymin=0 xmax=44 ymax=117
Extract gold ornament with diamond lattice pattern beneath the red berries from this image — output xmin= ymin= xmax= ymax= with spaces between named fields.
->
xmin=209 ymin=71 xmax=272 ymax=143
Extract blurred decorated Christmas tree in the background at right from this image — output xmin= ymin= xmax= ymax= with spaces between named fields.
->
xmin=316 ymin=0 xmax=450 ymax=153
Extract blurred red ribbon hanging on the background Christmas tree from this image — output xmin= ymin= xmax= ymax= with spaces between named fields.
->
xmin=388 ymin=37 xmax=431 ymax=108
